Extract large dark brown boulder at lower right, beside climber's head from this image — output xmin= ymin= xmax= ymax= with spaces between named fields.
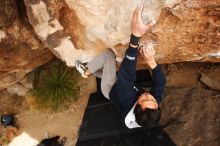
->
xmin=160 ymin=88 xmax=220 ymax=146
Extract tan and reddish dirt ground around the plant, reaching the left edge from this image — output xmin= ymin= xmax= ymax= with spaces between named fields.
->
xmin=0 ymin=76 xmax=96 ymax=146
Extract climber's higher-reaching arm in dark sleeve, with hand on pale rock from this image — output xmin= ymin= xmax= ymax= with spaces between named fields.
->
xmin=117 ymin=5 xmax=153 ymax=87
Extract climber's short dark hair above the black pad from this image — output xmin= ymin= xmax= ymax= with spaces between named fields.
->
xmin=134 ymin=104 xmax=161 ymax=127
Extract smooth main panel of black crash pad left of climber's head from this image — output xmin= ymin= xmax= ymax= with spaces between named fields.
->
xmin=79 ymin=99 xmax=126 ymax=140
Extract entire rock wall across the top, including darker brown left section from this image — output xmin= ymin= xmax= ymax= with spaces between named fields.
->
xmin=0 ymin=0 xmax=220 ymax=88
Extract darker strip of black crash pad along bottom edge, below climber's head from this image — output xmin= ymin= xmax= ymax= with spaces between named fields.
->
xmin=76 ymin=127 xmax=176 ymax=146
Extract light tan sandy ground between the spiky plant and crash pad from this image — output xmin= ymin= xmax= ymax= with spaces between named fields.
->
xmin=2 ymin=77 xmax=96 ymax=146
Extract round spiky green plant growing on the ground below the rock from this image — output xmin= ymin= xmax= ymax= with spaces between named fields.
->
xmin=33 ymin=61 xmax=77 ymax=111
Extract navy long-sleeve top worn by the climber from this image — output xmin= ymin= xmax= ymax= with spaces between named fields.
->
xmin=109 ymin=36 xmax=166 ymax=118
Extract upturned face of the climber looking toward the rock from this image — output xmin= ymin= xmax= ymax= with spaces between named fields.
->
xmin=137 ymin=92 xmax=158 ymax=110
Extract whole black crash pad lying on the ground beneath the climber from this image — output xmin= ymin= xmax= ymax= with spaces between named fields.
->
xmin=76 ymin=70 xmax=175 ymax=146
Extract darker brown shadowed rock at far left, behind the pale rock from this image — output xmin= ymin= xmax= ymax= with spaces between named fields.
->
xmin=0 ymin=0 xmax=54 ymax=90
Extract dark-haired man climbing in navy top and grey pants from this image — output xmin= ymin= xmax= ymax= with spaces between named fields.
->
xmin=75 ymin=6 xmax=165 ymax=128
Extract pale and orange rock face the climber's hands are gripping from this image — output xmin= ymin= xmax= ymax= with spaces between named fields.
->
xmin=25 ymin=0 xmax=220 ymax=66
